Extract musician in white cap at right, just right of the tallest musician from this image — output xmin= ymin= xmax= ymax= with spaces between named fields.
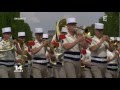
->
xmin=89 ymin=23 xmax=112 ymax=78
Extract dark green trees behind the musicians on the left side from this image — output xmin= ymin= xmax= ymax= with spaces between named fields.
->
xmin=0 ymin=12 xmax=32 ymax=42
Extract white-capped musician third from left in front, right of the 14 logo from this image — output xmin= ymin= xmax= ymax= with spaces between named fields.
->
xmin=31 ymin=28 xmax=49 ymax=78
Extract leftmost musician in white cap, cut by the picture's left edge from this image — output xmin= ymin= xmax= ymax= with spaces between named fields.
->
xmin=0 ymin=27 xmax=15 ymax=78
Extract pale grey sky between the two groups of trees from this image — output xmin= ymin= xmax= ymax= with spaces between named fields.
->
xmin=20 ymin=12 xmax=104 ymax=33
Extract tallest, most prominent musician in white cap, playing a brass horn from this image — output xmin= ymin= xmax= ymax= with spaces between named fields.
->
xmin=63 ymin=18 xmax=84 ymax=78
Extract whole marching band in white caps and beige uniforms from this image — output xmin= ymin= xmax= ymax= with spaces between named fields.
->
xmin=0 ymin=18 xmax=120 ymax=78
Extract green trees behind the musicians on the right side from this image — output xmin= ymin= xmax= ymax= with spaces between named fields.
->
xmin=99 ymin=12 xmax=119 ymax=37
